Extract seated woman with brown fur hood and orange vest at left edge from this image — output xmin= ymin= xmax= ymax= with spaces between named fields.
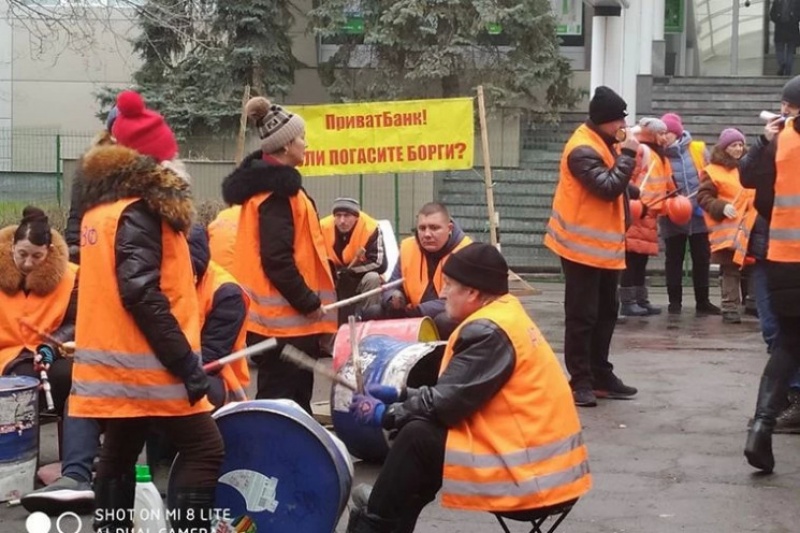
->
xmin=0 ymin=206 xmax=78 ymax=414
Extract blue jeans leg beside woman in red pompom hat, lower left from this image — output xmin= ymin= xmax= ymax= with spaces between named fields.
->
xmin=61 ymin=400 xmax=100 ymax=483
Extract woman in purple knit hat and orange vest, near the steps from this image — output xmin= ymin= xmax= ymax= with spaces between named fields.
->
xmin=697 ymin=128 xmax=755 ymax=324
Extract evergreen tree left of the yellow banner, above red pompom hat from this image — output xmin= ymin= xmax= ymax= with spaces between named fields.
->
xmin=98 ymin=0 xmax=298 ymax=139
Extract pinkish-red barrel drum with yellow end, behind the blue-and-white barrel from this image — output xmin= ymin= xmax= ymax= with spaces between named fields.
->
xmin=333 ymin=316 xmax=439 ymax=370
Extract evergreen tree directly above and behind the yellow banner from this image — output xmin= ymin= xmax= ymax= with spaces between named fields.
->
xmin=310 ymin=0 xmax=579 ymax=114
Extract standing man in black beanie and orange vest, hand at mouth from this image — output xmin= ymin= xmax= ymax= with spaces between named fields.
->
xmin=544 ymin=86 xmax=639 ymax=407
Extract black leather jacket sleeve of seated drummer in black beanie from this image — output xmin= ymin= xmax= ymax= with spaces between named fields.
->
xmin=382 ymin=319 xmax=517 ymax=430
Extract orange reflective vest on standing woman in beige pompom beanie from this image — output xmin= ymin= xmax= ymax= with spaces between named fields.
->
xmin=231 ymin=190 xmax=337 ymax=337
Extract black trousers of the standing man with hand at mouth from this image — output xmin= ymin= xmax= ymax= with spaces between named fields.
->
xmin=561 ymin=257 xmax=619 ymax=390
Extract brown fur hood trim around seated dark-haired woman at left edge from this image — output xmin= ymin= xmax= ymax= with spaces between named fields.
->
xmin=0 ymin=225 xmax=69 ymax=296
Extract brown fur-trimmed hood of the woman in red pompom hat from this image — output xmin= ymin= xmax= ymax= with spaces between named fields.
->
xmin=79 ymin=145 xmax=195 ymax=232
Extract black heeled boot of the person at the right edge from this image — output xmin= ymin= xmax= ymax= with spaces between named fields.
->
xmin=744 ymin=372 xmax=791 ymax=473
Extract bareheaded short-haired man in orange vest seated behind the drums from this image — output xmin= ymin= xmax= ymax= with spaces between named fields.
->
xmin=362 ymin=202 xmax=472 ymax=339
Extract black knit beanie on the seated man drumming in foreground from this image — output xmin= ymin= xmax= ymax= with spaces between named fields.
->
xmin=442 ymin=242 xmax=508 ymax=295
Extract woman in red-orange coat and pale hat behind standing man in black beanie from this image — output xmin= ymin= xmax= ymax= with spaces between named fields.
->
xmin=619 ymin=117 xmax=670 ymax=316
